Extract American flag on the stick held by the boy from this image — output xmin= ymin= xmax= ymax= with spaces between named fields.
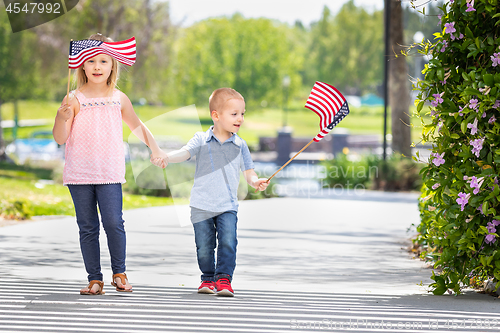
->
xmin=305 ymin=81 xmax=349 ymax=142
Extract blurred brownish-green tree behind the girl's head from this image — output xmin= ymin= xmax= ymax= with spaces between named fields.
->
xmin=28 ymin=0 xmax=175 ymax=101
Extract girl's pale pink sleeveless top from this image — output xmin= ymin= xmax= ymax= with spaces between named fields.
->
xmin=63 ymin=90 xmax=125 ymax=185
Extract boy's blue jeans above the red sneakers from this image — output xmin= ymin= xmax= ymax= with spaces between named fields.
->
xmin=193 ymin=210 xmax=238 ymax=281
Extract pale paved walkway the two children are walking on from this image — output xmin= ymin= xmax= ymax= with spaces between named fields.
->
xmin=0 ymin=194 xmax=500 ymax=332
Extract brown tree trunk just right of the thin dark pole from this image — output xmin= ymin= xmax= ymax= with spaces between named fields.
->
xmin=389 ymin=0 xmax=411 ymax=157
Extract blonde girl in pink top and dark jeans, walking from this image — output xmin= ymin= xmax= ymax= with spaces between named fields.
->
xmin=53 ymin=34 xmax=166 ymax=295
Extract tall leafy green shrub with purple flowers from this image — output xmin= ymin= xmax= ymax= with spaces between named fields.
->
xmin=415 ymin=0 xmax=500 ymax=294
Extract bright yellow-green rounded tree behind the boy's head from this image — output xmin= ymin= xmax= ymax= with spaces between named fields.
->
xmin=175 ymin=14 xmax=303 ymax=105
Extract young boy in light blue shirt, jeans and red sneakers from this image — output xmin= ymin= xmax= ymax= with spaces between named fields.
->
xmin=153 ymin=88 xmax=268 ymax=297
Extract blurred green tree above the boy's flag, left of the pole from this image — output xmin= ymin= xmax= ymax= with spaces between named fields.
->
xmin=306 ymin=0 xmax=383 ymax=94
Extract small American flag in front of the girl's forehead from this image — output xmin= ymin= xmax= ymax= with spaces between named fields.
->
xmin=68 ymin=37 xmax=136 ymax=69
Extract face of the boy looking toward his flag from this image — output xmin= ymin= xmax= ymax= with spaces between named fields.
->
xmin=212 ymin=98 xmax=245 ymax=133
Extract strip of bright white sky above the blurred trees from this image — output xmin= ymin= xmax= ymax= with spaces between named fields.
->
xmin=169 ymin=0 xmax=384 ymax=26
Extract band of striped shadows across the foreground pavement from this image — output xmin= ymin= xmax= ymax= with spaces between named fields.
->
xmin=0 ymin=276 xmax=500 ymax=333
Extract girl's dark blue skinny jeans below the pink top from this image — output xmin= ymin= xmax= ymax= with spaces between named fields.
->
xmin=68 ymin=184 xmax=126 ymax=281
